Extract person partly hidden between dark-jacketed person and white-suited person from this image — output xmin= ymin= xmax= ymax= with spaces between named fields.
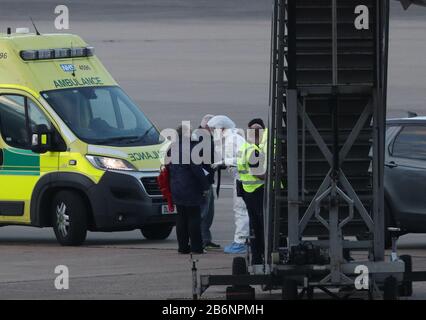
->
xmin=192 ymin=114 xmax=220 ymax=250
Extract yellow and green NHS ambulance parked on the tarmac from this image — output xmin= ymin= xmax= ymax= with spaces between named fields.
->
xmin=0 ymin=29 xmax=176 ymax=246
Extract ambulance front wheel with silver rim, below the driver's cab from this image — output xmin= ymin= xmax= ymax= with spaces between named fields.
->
xmin=51 ymin=190 xmax=87 ymax=246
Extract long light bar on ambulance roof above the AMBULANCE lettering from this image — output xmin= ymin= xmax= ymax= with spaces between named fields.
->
xmin=20 ymin=47 xmax=95 ymax=61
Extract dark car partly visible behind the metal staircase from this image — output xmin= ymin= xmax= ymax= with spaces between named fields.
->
xmin=385 ymin=117 xmax=426 ymax=242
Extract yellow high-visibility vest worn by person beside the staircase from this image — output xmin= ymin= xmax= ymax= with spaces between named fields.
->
xmin=237 ymin=142 xmax=264 ymax=193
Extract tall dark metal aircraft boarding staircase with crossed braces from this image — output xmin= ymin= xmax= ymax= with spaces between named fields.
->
xmin=265 ymin=0 xmax=389 ymax=283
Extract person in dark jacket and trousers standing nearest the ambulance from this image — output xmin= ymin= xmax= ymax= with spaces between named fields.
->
xmin=169 ymin=127 xmax=210 ymax=254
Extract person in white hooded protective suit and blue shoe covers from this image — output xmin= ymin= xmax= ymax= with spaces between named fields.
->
xmin=207 ymin=115 xmax=250 ymax=254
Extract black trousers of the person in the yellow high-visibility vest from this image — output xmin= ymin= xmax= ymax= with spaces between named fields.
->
xmin=243 ymin=187 xmax=265 ymax=264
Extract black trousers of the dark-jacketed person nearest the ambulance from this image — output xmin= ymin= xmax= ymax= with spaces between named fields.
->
xmin=176 ymin=205 xmax=203 ymax=253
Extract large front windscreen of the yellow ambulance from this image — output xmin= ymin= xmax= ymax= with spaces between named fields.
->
xmin=42 ymin=87 xmax=160 ymax=146
